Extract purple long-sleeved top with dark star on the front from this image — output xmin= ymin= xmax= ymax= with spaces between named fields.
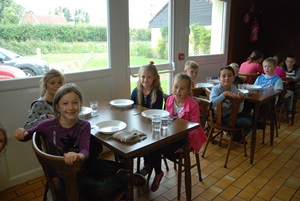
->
xmin=25 ymin=118 xmax=91 ymax=159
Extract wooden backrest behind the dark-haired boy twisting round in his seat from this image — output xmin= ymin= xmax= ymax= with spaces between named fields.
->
xmin=214 ymin=97 xmax=243 ymax=128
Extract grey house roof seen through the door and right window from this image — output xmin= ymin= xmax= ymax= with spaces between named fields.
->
xmin=149 ymin=0 xmax=212 ymax=28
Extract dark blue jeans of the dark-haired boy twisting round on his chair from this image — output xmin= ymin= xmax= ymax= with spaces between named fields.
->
xmin=222 ymin=113 xmax=252 ymax=142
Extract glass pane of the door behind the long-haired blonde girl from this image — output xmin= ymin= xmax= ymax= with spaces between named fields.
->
xmin=129 ymin=0 xmax=169 ymax=92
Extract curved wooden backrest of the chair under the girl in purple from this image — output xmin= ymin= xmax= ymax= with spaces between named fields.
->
xmin=32 ymin=133 xmax=82 ymax=201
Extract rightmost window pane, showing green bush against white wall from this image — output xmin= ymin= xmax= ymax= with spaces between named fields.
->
xmin=189 ymin=0 xmax=225 ymax=56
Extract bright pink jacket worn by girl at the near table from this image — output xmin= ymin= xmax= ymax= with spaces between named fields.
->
xmin=166 ymin=95 xmax=207 ymax=153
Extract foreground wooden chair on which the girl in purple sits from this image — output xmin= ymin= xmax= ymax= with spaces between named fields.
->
xmin=32 ymin=133 xmax=125 ymax=201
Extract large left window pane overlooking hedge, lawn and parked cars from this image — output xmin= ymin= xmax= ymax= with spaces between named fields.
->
xmin=0 ymin=0 xmax=108 ymax=79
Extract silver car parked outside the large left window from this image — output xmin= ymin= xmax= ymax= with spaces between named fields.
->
xmin=0 ymin=48 xmax=49 ymax=76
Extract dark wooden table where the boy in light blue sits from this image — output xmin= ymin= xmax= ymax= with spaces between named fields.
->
xmin=245 ymin=90 xmax=281 ymax=164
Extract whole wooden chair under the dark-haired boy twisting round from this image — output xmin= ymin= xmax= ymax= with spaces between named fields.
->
xmin=202 ymin=97 xmax=247 ymax=168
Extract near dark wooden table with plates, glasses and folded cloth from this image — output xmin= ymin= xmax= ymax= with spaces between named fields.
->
xmin=88 ymin=101 xmax=199 ymax=200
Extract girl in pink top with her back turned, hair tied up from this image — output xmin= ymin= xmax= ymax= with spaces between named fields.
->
xmin=239 ymin=50 xmax=264 ymax=84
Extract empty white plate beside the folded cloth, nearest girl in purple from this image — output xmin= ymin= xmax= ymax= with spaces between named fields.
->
xmin=94 ymin=120 xmax=127 ymax=134
